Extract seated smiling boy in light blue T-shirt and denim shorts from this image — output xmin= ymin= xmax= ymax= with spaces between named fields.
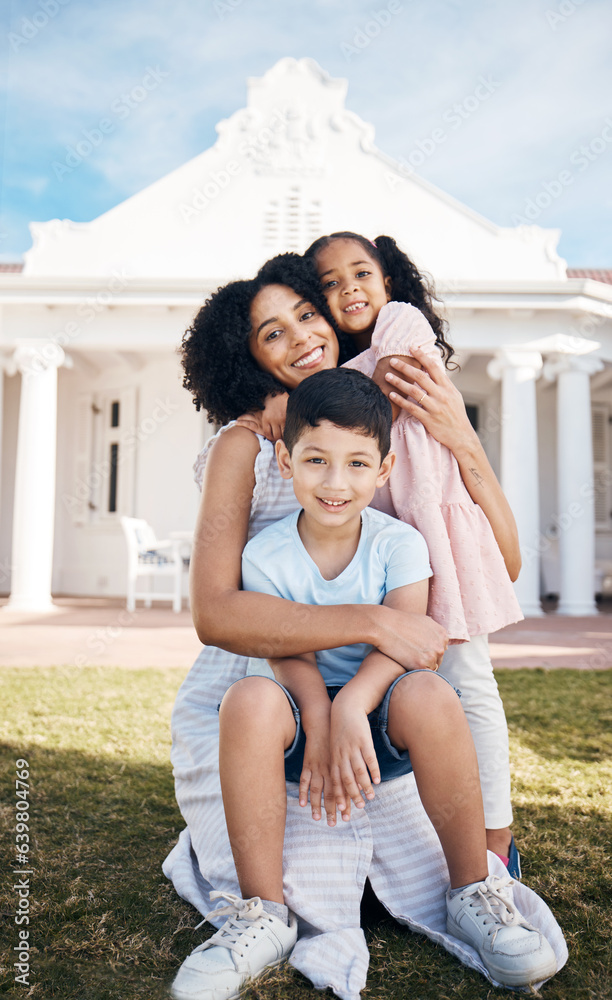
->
xmin=173 ymin=368 xmax=556 ymax=1000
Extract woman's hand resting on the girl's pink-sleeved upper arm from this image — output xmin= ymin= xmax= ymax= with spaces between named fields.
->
xmin=385 ymin=348 xmax=480 ymax=458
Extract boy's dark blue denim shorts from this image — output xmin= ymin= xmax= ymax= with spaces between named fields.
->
xmin=262 ymin=670 xmax=459 ymax=781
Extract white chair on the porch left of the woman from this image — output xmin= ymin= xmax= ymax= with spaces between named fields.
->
xmin=121 ymin=517 xmax=183 ymax=611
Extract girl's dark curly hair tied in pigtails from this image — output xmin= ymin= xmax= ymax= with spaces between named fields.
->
xmin=304 ymin=232 xmax=458 ymax=368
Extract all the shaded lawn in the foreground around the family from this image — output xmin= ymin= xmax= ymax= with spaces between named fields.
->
xmin=0 ymin=745 xmax=612 ymax=1000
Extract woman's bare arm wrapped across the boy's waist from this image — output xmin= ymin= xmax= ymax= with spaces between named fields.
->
xmin=190 ymin=427 xmax=447 ymax=669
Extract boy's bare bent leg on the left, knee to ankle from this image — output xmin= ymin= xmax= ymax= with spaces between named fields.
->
xmin=219 ymin=676 xmax=296 ymax=903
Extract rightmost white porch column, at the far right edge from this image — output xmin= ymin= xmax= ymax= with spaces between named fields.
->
xmin=544 ymin=354 xmax=603 ymax=616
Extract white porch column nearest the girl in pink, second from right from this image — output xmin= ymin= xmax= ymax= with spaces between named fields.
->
xmin=487 ymin=347 xmax=543 ymax=617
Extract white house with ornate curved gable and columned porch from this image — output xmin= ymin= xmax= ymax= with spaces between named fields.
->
xmin=0 ymin=59 xmax=612 ymax=614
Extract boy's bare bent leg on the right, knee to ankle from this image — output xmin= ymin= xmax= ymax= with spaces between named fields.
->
xmin=387 ymin=671 xmax=488 ymax=889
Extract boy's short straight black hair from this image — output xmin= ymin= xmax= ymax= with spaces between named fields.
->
xmin=283 ymin=368 xmax=393 ymax=461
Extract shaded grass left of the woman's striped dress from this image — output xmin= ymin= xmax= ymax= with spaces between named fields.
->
xmin=0 ymin=744 xmax=191 ymax=1000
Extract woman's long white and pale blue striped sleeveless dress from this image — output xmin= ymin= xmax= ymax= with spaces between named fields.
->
xmin=163 ymin=424 xmax=567 ymax=1000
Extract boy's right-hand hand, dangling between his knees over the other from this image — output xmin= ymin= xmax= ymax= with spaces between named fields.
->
xmin=330 ymin=688 xmax=380 ymax=821
